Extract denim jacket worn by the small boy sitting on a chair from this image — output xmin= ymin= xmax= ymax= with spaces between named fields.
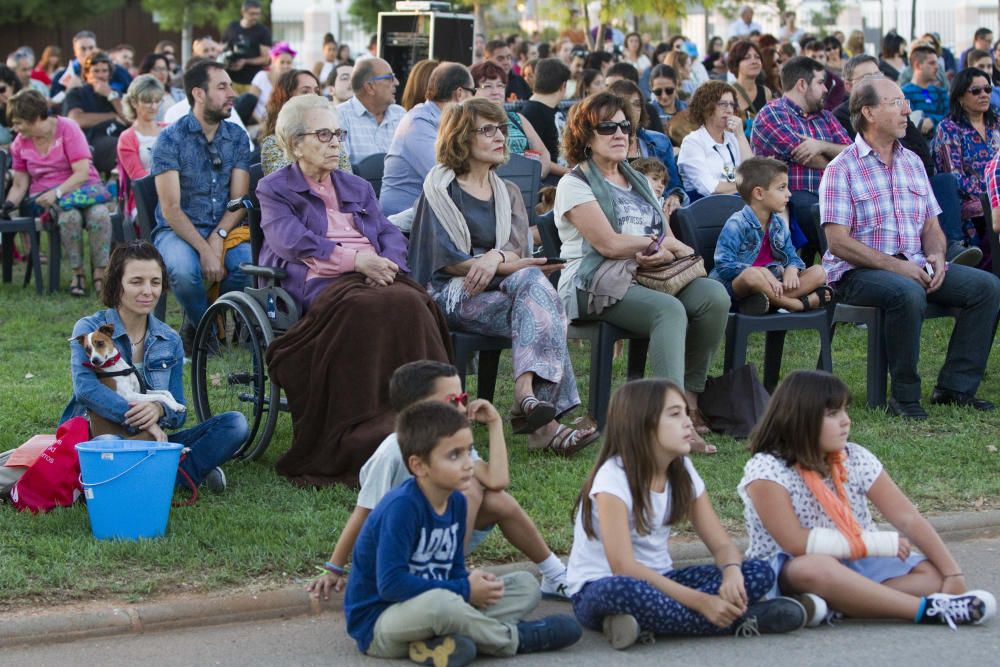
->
xmin=710 ymin=204 xmax=806 ymax=284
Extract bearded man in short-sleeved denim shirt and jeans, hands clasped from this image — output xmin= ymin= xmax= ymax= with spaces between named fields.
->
xmin=150 ymin=61 xmax=250 ymax=325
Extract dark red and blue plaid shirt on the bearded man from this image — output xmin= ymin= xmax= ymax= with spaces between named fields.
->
xmin=750 ymin=97 xmax=851 ymax=192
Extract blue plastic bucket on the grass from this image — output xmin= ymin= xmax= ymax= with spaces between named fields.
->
xmin=76 ymin=439 xmax=183 ymax=540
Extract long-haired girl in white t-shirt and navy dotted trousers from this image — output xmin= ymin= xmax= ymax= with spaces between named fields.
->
xmin=567 ymin=379 xmax=805 ymax=649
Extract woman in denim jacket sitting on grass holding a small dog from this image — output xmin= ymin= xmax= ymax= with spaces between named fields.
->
xmin=60 ymin=241 xmax=249 ymax=491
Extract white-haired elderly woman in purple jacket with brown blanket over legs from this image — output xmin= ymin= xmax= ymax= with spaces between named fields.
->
xmin=257 ymin=95 xmax=449 ymax=485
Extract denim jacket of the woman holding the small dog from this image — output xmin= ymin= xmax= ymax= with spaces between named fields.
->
xmin=59 ymin=308 xmax=187 ymax=429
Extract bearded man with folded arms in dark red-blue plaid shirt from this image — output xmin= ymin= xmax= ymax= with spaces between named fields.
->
xmin=750 ymin=56 xmax=851 ymax=256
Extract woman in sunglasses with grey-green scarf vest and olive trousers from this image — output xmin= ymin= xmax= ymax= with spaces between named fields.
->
xmin=554 ymin=91 xmax=729 ymax=453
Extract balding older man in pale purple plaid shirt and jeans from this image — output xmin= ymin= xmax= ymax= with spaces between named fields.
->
xmin=819 ymin=77 xmax=1000 ymax=419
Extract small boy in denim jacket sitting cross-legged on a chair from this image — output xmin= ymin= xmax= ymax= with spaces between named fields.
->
xmin=710 ymin=157 xmax=833 ymax=315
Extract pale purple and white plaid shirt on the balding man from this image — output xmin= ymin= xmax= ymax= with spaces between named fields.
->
xmin=819 ymin=133 xmax=941 ymax=283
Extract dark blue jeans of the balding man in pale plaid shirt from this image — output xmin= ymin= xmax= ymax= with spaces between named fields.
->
xmin=837 ymin=264 xmax=1000 ymax=403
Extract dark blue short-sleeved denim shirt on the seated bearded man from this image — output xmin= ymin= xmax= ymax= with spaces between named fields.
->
xmin=149 ymin=113 xmax=250 ymax=237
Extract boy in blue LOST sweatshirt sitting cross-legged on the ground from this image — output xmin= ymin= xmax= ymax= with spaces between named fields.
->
xmin=344 ymin=401 xmax=582 ymax=666
